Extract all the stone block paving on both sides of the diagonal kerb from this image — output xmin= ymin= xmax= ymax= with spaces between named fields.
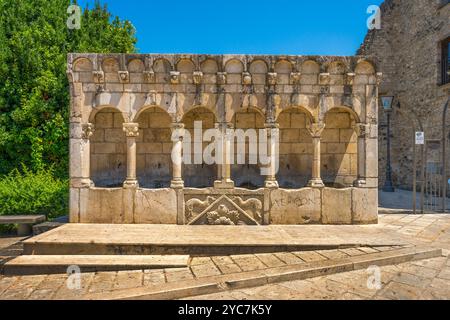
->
xmin=0 ymin=214 xmax=450 ymax=300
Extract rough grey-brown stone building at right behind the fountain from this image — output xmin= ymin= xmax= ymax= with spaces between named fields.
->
xmin=359 ymin=0 xmax=450 ymax=190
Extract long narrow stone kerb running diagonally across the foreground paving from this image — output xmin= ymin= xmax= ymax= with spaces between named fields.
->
xmin=83 ymin=247 xmax=442 ymax=300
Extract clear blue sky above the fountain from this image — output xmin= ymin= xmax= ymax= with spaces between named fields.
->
xmin=79 ymin=0 xmax=382 ymax=55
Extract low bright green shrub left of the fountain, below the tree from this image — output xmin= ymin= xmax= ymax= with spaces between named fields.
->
xmin=0 ymin=167 xmax=69 ymax=220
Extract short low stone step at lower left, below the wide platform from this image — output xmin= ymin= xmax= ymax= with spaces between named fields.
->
xmin=1 ymin=255 xmax=189 ymax=275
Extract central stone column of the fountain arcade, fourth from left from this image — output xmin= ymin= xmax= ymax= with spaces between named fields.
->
xmin=214 ymin=123 xmax=234 ymax=189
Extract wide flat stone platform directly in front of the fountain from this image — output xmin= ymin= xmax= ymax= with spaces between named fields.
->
xmin=23 ymin=224 xmax=406 ymax=255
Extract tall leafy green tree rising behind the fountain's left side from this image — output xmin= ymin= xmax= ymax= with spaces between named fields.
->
xmin=0 ymin=0 xmax=136 ymax=178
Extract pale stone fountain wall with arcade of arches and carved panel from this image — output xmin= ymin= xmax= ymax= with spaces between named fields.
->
xmin=68 ymin=54 xmax=381 ymax=225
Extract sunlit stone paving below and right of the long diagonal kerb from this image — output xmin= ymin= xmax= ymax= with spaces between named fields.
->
xmin=185 ymin=214 xmax=450 ymax=300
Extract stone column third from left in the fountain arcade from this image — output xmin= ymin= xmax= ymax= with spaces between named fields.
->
xmin=170 ymin=123 xmax=185 ymax=189
